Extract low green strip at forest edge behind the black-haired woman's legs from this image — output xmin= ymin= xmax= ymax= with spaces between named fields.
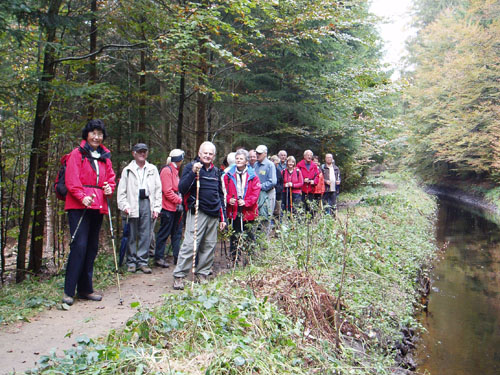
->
xmin=0 ymin=252 xmax=116 ymax=324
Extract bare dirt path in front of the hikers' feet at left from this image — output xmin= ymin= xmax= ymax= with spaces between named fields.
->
xmin=0 ymin=250 xmax=227 ymax=374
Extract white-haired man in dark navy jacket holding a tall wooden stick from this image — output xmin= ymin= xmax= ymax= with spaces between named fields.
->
xmin=174 ymin=142 xmax=226 ymax=289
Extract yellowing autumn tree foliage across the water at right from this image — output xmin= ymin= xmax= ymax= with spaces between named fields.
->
xmin=406 ymin=0 xmax=500 ymax=182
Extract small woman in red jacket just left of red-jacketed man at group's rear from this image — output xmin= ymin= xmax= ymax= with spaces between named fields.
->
xmin=281 ymin=156 xmax=304 ymax=213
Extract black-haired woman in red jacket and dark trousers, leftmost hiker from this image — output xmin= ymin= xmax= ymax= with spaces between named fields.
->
xmin=62 ymin=120 xmax=116 ymax=305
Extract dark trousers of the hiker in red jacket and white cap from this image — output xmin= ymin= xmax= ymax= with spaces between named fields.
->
xmin=155 ymin=209 xmax=184 ymax=260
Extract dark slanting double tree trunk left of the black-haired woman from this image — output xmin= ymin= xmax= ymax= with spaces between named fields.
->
xmin=16 ymin=0 xmax=62 ymax=283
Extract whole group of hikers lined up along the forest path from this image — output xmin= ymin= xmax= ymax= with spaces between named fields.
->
xmin=62 ymin=120 xmax=340 ymax=305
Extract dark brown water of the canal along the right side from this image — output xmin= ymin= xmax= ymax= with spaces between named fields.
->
xmin=418 ymin=200 xmax=500 ymax=375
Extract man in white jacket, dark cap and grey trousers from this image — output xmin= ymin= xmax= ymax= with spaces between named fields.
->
xmin=117 ymin=143 xmax=161 ymax=273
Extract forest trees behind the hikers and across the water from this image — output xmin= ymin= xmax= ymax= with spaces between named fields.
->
xmin=0 ymin=0 xmax=500 ymax=281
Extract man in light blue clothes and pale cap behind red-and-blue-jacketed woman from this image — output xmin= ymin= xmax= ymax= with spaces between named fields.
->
xmin=254 ymin=145 xmax=277 ymax=218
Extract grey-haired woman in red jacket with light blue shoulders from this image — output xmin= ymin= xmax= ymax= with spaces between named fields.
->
xmin=224 ymin=149 xmax=261 ymax=259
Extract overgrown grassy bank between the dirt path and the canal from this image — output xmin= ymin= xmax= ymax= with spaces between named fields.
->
xmin=29 ymin=176 xmax=435 ymax=375
